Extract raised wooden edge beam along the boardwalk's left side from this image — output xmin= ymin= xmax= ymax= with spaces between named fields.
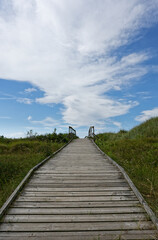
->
xmin=0 ymin=139 xmax=73 ymax=219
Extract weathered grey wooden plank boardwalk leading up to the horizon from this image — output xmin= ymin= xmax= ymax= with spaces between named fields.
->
xmin=0 ymin=139 xmax=156 ymax=240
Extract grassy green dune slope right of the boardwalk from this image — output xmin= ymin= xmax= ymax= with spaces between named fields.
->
xmin=95 ymin=117 xmax=158 ymax=217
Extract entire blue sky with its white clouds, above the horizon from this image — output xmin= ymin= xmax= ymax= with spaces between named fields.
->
xmin=0 ymin=0 xmax=158 ymax=137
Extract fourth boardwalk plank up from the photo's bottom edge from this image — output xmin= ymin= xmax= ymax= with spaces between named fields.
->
xmin=8 ymin=207 xmax=144 ymax=215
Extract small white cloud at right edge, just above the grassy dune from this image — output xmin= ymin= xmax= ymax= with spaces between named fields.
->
xmin=135 ymin=107 xmax=158 ymax=122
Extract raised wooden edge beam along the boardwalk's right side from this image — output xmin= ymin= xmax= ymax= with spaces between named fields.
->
xmin=91 ymin=139 xmax=158 ymax=229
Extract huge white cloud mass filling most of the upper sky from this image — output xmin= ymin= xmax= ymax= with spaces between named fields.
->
xmin=0 ymin=0 xmax=158 ymax=125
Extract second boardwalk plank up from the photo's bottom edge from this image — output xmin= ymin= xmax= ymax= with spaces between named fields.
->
xmin=0 ymin=221 xmax=154 ymax=232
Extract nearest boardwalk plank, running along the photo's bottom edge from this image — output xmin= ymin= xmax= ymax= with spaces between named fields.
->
xmin=0 ymin=230 xmax=157 ymax=240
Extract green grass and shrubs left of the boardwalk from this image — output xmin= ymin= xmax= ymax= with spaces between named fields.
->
xmin=0 ymin=130 xmax=69 ymax=207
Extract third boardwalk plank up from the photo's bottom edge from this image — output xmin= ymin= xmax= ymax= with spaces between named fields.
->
xmin=3 ymin=213 xmax=147 ymax=223
